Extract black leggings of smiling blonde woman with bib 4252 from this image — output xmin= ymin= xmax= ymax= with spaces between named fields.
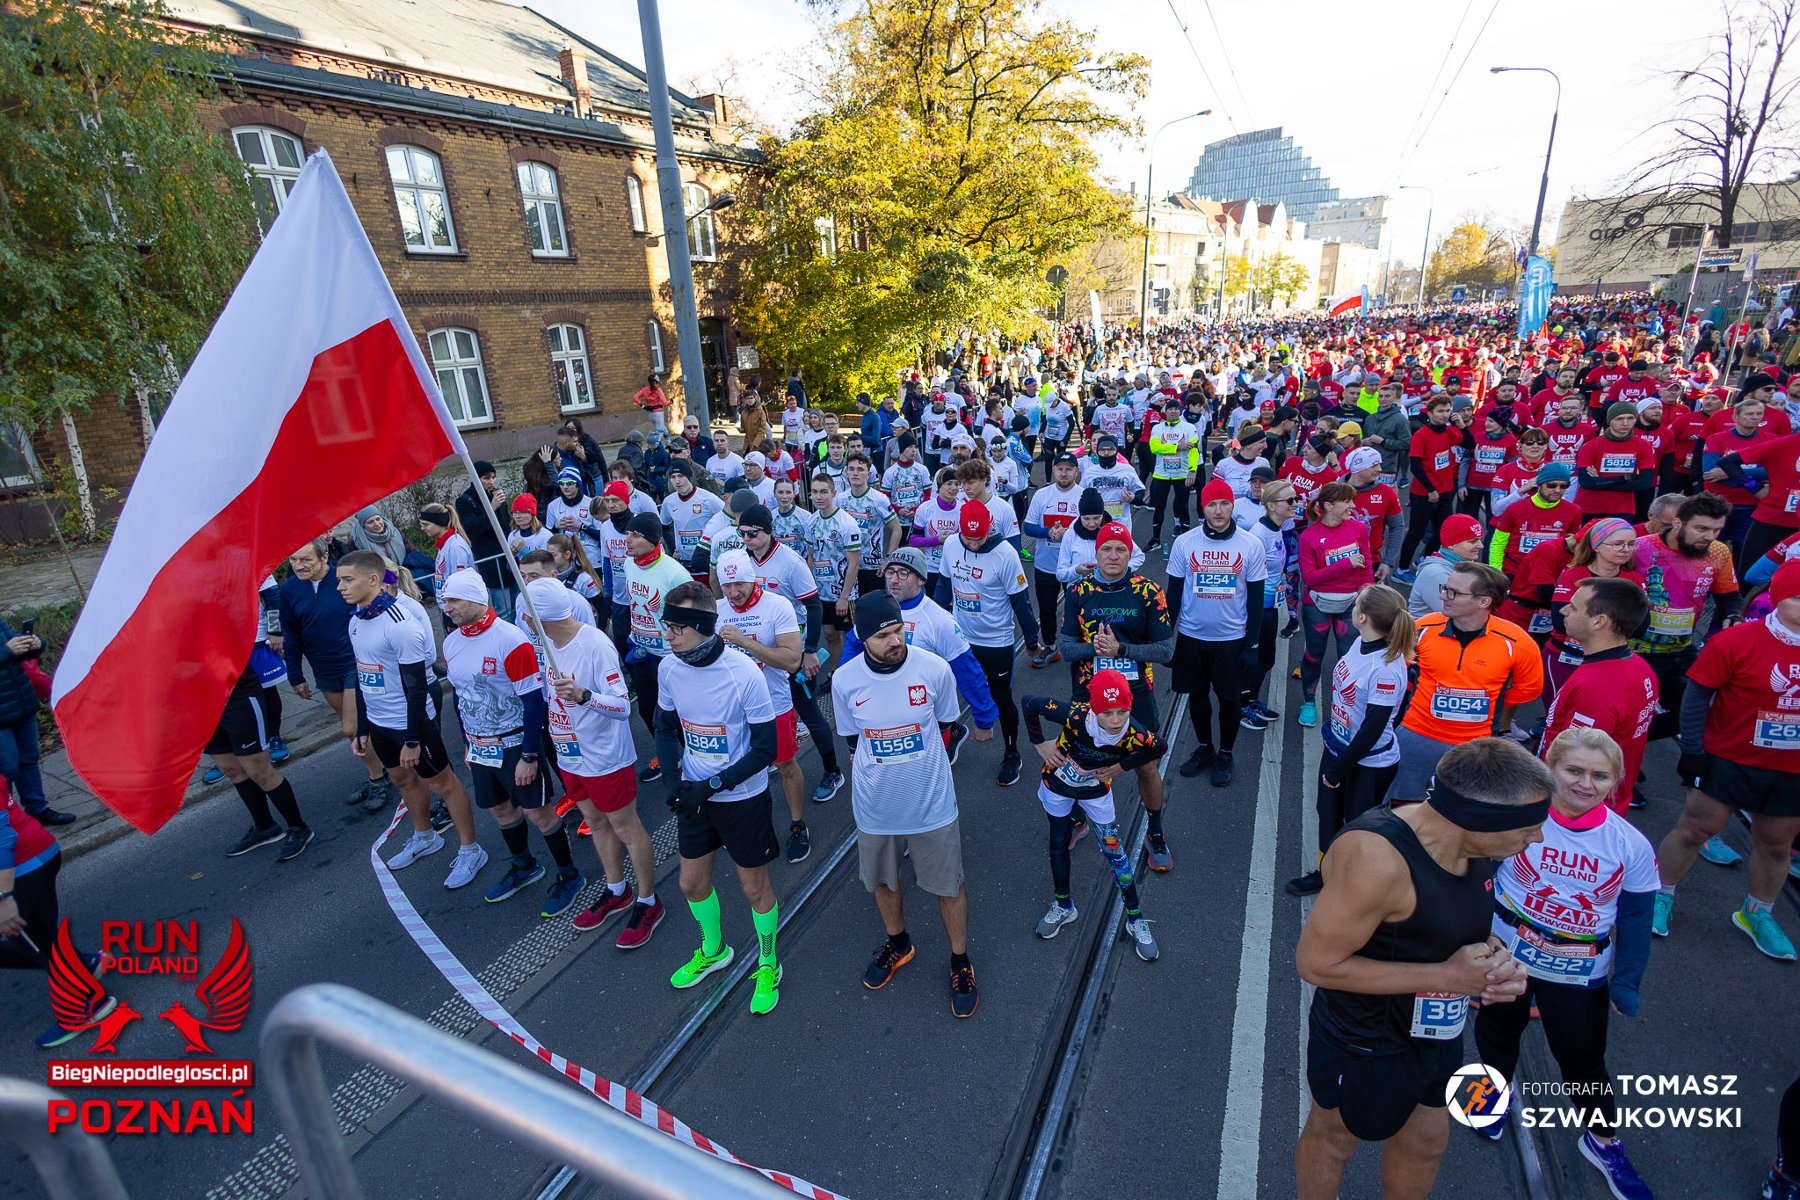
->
xmin=1474 ymin=979 xmax=1618 ymax=1135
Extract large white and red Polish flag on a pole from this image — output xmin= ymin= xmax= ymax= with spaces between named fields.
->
xmin=50 ymin=151 xmax=463 ymax=833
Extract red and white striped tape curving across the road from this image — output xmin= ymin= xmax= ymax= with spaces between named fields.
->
xmin=369 ymin=806 xmax=844 ymax=1200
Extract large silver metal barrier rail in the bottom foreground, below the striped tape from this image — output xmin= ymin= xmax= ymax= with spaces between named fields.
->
xmin=262 ymin=984 xmax=792 ymax=1200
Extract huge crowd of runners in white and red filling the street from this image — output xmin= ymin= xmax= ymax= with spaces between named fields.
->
xmin=0 ymin=295 xmax=1800 ymax=1200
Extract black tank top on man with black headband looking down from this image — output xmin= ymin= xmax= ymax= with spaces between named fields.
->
xmin=1312 ymin=804 xmax=1494 ymax=1054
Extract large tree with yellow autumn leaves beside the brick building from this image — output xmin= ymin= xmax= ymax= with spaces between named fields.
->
xmin=743 ymin=0 xmax=1147 ymax=394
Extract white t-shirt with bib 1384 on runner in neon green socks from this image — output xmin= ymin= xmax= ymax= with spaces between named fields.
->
xmin=657 ymin=646 xmax=776 ymax=804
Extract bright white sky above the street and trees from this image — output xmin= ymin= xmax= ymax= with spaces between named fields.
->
xmin=529 ymin=0 xmax=1715 ymax=263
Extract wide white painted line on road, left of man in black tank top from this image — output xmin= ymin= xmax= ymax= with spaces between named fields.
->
xmin=1213 ymin=639 xmax=1292 ymax=1196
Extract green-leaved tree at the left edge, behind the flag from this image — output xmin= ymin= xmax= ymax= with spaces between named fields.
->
xmin=0 ymin=0 xmax=256 ymax=531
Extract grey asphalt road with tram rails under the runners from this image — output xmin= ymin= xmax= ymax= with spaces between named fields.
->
xmin=0 ymin=525 xmax=1800 ymax=1200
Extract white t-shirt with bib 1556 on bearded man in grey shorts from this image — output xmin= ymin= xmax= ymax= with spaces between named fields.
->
xmin=832 ymin=646 xmax=963 ymax=837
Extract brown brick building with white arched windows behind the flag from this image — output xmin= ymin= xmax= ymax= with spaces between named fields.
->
xmin=0 ymin=0 xmax=760 ymax=542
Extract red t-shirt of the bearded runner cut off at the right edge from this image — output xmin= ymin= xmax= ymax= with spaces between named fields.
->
xmin=1688 ymin=613 xmax=1800 ymax=773
